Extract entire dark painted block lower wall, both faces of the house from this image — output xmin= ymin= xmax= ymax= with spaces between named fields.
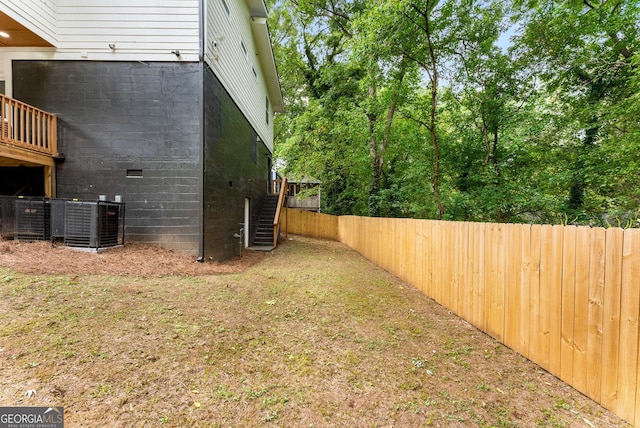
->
xmin=13 ymin=61 xmax=270 ymax=260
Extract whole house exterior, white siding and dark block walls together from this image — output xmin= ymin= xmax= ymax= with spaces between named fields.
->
xmin=0 ymin=0 xmax=281 ymax=260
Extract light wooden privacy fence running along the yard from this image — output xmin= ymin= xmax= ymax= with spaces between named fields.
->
xmin=287 ymin=210 xmax=640 ymax=426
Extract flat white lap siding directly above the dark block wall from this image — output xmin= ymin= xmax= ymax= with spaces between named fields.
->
xmin=57 ymin=0 xmax=200 ymax=60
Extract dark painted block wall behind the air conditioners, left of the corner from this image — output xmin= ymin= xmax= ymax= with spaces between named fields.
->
xmin=13 ymin=61 xmax=202 ymax=255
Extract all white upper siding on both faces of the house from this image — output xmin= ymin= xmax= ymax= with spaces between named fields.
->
xmin=0 ymin=0 xmax=273 ymax=150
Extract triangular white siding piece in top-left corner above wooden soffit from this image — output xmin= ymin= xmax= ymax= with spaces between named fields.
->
xmin=0 ymin=0 xmax=57 ymax=46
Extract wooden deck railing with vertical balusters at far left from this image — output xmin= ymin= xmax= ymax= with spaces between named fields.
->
xmin=0 ymin=95 xmax=58 ymax=156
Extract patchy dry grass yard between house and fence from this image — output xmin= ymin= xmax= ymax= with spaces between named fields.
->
xmin=0 ymin=237 xmax=626 ymax=427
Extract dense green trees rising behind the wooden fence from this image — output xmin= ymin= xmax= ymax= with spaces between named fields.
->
xmin=270 ymin=0 xmax=640 ymax=225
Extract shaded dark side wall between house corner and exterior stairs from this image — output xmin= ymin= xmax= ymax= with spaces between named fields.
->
xmin=204 ymin=63 xmax=271 ymax=260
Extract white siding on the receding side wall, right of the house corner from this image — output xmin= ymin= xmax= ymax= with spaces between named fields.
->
xmin=205 ymin=0 xmax=273 ymax=150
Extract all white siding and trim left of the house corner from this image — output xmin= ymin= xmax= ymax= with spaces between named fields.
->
xmin=0 ymin=0 xmax=200 ymax=87
